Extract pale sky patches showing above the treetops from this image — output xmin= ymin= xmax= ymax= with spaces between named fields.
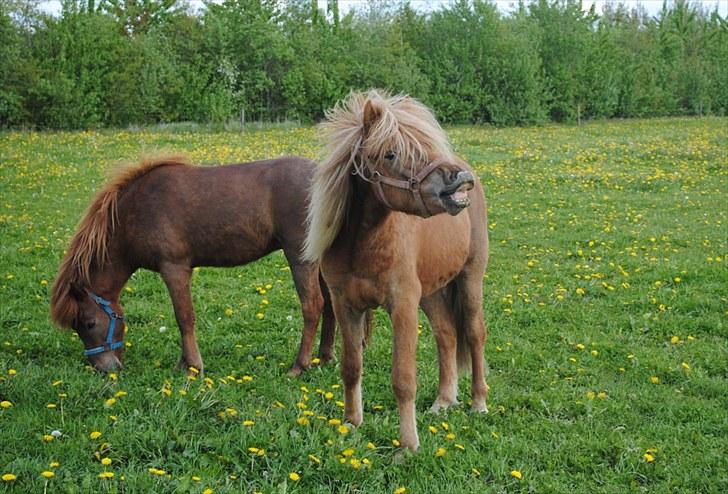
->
xmin=40 ymin=0 xmax=728 ymax=17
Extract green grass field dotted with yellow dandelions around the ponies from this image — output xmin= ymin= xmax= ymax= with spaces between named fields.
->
xmin=0 ymin=118 xmax=728 ymax=493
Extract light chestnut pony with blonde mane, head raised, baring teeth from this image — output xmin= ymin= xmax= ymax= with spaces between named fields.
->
xmin=304 ymin=91 xmax=488 ymax=450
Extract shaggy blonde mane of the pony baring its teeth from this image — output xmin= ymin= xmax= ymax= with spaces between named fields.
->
xmin=303 ymin=90 xmax=452 ymax=262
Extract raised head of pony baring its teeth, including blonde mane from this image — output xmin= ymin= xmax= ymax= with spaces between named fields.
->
xmin=304 ymin=91 xmax=475 ymax=260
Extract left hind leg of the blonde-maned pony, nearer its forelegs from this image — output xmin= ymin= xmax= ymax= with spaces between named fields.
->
xmin=420 ymin=289 xmax=458 ymax=413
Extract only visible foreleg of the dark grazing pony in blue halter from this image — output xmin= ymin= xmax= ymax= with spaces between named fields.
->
xmin=159 ymin=264 xmax=203 ymax=374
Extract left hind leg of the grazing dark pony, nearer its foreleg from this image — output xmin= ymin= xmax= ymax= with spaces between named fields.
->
xmin=288 ymin=264 xmax=324 ymax=376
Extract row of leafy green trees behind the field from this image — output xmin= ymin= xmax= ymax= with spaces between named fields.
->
xmin=0 ymin=0 xmax=728 ymax=129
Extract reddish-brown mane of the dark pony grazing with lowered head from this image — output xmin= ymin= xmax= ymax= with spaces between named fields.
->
xmin=51 ymin=156 xmax=189 ymax=328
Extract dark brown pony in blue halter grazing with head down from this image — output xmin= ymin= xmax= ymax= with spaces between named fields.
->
xmin=51 ymin=157 xmax=335 ymax=375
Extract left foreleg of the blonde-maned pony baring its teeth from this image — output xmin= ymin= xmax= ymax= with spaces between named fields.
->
xmin=333 ymin=298 xmax=366 ymax=426
